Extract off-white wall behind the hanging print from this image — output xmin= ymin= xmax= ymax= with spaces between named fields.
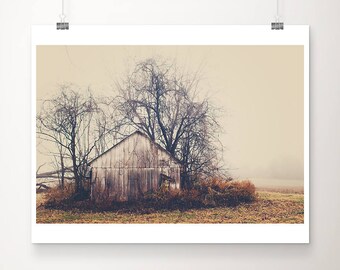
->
xmin=0 ymin=0 xmax=340 ymax=270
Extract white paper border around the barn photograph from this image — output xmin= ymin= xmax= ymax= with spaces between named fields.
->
xmin=31 ymin=25 xmax=309 ymax=243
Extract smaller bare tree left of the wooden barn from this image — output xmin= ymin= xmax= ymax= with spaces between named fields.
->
xmin=37 ymin=86 xmax=105 ymax=194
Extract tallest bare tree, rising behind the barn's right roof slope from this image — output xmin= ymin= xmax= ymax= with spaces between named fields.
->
xmin=118 ymin=59 xmax=223 ymax=187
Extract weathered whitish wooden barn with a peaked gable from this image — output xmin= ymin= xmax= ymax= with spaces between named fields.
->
xmin=89 ymin=131 xmax=181 ymax=201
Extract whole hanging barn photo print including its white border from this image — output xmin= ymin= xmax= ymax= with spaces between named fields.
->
xmin=31 ymin=25 xmax=309 ymax=243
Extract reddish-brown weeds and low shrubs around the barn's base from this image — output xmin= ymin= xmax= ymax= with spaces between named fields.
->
xmin=44 ymin=179 xmax=256 ymax=213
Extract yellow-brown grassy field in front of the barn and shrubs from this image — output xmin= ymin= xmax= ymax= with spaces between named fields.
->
xmin=37 ymin=191 xmax=304 ymax=224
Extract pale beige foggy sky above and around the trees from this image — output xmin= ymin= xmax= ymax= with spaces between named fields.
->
xmin=37 ymin=46 xmax=304 ymax=179
